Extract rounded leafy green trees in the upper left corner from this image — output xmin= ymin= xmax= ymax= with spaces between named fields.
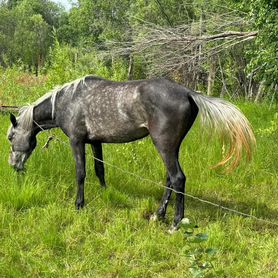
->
xmin=0 ymin=0 xmax=60 ymax=70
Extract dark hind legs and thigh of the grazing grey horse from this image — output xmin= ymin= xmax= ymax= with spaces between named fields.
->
xmin=149 ymin=100 xmax=198 ymax=229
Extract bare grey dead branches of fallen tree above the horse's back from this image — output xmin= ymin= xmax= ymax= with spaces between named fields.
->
xmin=108 ymin=12 xmax=257 ymax=78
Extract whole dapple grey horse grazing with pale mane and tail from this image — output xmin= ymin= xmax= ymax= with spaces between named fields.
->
xmin=8 ymin=76 xmax=255 ymax=228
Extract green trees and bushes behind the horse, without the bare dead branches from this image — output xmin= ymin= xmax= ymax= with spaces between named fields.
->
xmin=0 ymin=0 xmax=278 ymax=100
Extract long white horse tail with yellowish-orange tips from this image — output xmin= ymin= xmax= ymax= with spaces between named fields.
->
xmin=190 ymin=93 xmax=256 ymax=170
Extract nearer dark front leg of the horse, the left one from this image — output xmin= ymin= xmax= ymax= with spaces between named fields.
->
xmin=71 ymin=140 xmax=86 ymax=209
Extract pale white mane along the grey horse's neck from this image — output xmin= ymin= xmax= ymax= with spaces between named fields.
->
xmin=17 ymin=76 xmax=88 ymax=130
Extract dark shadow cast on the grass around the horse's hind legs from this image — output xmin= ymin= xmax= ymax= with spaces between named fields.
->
xmin=103 ymin=177 xmax=278 ymax=231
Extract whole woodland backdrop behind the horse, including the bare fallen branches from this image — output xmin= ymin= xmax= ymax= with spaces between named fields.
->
xmin=0 ymin=0 xmax=278 ymax=104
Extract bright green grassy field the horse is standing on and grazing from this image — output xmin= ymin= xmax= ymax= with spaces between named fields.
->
xmin=0 ymin=75 xmax=278 ymax=278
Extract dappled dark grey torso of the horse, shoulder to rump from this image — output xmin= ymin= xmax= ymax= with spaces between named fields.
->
xmin=54 ymin=78 xmax=193 ymax=143
